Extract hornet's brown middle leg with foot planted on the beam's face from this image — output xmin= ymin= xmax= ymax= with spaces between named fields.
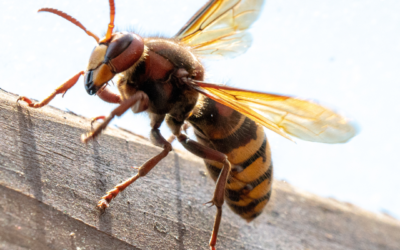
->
xmin=97 ymin=115 xmax=172 ymax=209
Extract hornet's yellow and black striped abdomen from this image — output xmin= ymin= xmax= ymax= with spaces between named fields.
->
xmin=189 ymin=97 xmax=272 ymax=221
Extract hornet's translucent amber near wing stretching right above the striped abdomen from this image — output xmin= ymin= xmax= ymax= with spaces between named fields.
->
xmin=194 ymin=81 xmax=357 ymax=143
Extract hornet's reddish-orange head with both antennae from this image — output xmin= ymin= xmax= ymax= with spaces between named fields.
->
xmin=39 ymin=0 xmax=144 ymax=95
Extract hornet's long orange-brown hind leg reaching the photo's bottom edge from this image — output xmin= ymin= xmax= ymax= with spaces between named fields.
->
xmin=177 ymin=134 xmax=231 ymax=250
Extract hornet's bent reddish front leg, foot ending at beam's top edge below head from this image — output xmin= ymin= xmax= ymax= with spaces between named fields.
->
xmin=81 ymin=91 xmax=149 ymax=143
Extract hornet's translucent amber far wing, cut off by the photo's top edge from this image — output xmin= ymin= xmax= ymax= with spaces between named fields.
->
xmin=175 ymin=0 xmax=264 ymax=58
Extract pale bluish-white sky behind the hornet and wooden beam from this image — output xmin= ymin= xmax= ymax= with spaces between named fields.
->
xmin=0 ymin=0 xmax=400 ymax=218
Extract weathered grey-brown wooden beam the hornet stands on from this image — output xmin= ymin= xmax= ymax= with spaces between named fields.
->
xmin=0 ymin=90 xmax=400 ymax=250
